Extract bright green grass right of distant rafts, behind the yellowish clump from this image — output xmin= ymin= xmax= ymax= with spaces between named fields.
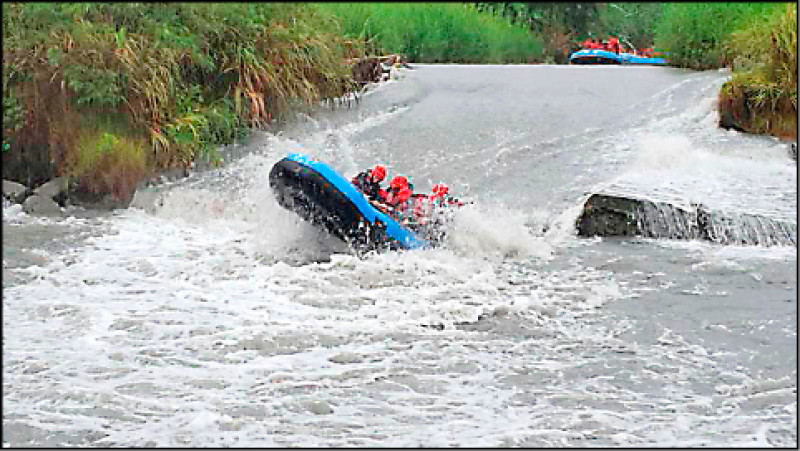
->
xmin=655 ymin=2 xmax=785 ymax=69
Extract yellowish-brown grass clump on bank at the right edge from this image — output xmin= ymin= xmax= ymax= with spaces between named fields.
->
xmin=720 ymin=4 xmax=797 ymax=140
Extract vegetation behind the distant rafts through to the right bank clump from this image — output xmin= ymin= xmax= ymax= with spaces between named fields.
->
xmin=476 ymin=2 xmax=797 ymax=139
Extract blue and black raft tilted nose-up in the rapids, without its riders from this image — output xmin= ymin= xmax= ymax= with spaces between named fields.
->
xmin=269 ymin=153 xmax=432 ymax=251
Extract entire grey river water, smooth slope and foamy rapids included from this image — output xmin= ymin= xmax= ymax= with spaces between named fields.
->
xmin=3 ymin=65 xmax=797 ymax=447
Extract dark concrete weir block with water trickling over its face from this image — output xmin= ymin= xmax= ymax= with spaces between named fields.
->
xmin=575 ymin=194 xmax=797 ymax=246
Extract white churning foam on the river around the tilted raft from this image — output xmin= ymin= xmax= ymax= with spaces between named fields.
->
xmin=3 ymin=66 xmax=797 ymax=447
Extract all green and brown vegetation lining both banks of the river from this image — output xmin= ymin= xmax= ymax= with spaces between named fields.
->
xmin=2 ymin=2 xmax=797 ymax=197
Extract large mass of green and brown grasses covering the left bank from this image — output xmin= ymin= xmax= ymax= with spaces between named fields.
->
xmin=3 ymin=3 xmax=361 ymax=196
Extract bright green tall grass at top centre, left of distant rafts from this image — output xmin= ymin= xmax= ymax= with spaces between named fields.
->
xmin=319 ymin=3 xmax=542 ymax=64
